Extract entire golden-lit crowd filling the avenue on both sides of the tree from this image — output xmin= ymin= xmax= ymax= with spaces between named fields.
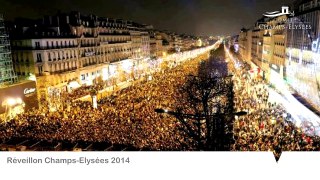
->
xmin=0 ymin=44 xmax=320 ymax=152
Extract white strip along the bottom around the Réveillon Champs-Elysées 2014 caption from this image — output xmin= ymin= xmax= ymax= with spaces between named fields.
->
xmin=0 ymin=152 xmax=320 ymax=180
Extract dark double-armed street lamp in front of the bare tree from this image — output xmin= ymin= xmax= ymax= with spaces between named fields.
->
xmin=155 ymin=109 xmax=247 ymax=150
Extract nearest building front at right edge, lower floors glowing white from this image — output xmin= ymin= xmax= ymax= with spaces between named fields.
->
xmin=285 ymin=10 xmax=320 ymax=107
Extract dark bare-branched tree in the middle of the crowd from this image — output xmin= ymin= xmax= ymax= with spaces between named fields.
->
xmin=176 ymin=47 xmax=234 ymax=151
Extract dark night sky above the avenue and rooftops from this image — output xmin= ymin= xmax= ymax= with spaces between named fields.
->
xmin=0 ymin=0 xmax=293 ymax=35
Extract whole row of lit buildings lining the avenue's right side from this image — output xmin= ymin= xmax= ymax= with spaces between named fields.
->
xmin=239 ymin=0 xmax=320 ymax=110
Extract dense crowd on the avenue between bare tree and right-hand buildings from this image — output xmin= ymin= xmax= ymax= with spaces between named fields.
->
xmin=229 ymin=47 xmax=320 ymax=153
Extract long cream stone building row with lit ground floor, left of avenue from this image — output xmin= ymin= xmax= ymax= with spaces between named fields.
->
xmin=11 ymin=12 xmax=150 ymax=103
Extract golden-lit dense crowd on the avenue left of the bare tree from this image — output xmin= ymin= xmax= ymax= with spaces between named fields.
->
xmin=0 ymin=52 xmax=209 ymax=150
